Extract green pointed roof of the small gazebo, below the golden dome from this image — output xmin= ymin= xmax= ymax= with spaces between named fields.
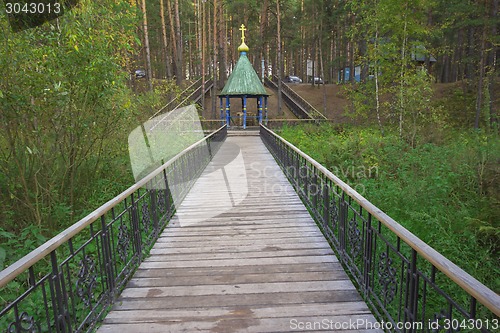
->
xmin=220 ymin=52 xmax=269 ymax=96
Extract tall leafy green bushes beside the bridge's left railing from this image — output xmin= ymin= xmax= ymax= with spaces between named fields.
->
xmin=0 ymin=0 xmax=163 ymax=267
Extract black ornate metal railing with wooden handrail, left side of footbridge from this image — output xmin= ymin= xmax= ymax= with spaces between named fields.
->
xmin=0 ymin=126 xmax=227 ymax=332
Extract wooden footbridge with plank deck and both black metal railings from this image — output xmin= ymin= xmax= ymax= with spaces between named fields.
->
xmin=0 ymin=125 xmax=500 ymax=333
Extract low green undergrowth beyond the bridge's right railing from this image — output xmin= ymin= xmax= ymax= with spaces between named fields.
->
xmin=282 ymin=125 xmax=500 ymax=291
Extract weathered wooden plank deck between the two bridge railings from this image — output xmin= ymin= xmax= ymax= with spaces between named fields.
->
xmin=98 ymin=136 xmax=380 ymax=333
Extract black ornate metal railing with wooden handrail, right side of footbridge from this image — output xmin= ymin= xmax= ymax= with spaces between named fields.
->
xmin=260 ymin=126 xmax=500 ymax=332
